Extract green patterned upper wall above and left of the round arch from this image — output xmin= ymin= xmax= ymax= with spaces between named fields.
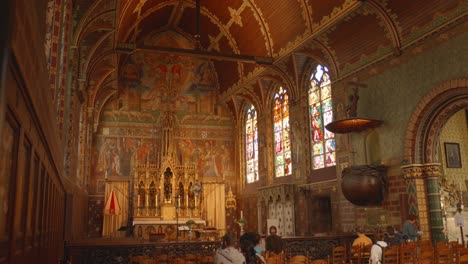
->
xmin=352 ymin=32 xmax=468 ymax=164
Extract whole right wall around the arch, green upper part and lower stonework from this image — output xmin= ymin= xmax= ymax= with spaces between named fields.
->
xmin=340 ymin=29 xmax=468 ymax=230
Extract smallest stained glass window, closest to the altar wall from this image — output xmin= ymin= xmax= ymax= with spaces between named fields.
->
xmin=245 ymin=105 xmax=258 ymax=183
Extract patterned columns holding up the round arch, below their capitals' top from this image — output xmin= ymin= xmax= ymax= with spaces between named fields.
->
xmin=401 ymin=163 xmax=444 ymax=241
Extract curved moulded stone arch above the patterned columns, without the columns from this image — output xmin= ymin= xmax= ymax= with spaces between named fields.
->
xmin=404 ymin=78 xmax=468 ymax=164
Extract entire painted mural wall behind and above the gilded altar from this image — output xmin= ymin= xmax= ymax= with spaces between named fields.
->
xmin=89 ymin=31 xmax=235 ymax=199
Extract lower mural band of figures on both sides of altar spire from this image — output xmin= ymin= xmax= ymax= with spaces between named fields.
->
xmin=93 ymin=136 xmax=234 ymax=179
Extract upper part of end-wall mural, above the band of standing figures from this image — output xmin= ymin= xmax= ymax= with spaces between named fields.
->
xmin=101 ymin=31 xmax=222 ymax=125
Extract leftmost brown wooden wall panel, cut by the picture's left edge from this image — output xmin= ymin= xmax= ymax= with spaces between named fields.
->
xmin=0 ymin=117 xmax=18 ymax=238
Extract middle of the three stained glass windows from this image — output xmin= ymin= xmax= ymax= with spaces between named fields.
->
xmin=273 ymin=87 xmax=292 ymax=177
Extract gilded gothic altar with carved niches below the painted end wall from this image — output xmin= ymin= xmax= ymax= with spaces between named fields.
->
xmin=132 ymin=147 xmax=206 ymax=241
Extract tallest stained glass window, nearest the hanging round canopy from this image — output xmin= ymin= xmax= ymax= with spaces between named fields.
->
xmin=309 ymin=65 xmax=336 ymax=170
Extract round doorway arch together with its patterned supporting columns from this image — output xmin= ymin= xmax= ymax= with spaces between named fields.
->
xmin=402 ymin=78 xmax=468 ymax=241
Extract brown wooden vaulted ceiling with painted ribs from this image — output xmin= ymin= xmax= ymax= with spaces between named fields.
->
xmin=73 ymin=0 xmax=468 ymax=121
